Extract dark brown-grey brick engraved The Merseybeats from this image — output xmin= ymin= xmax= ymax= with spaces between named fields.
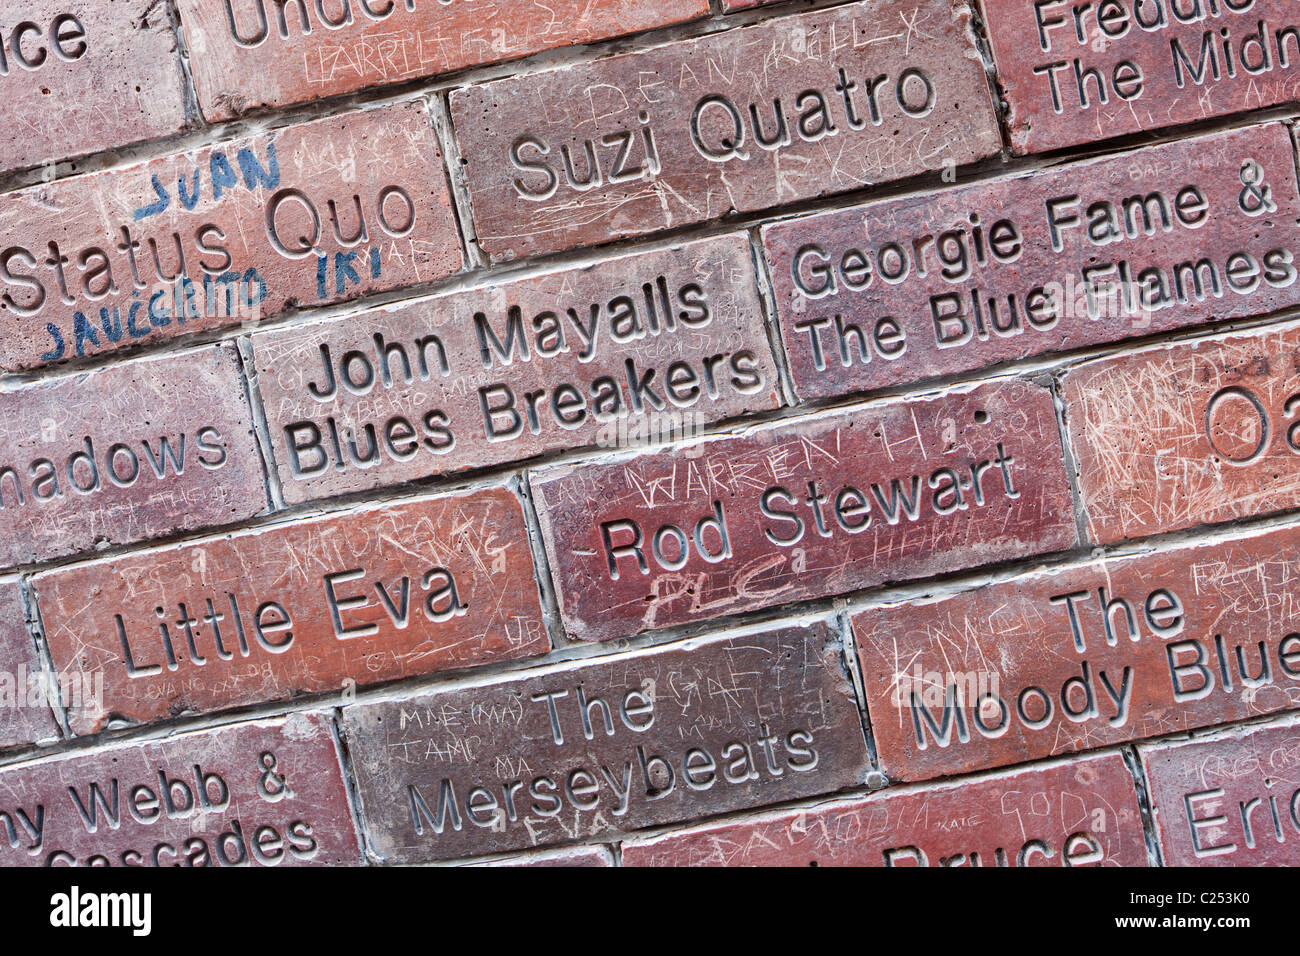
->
xmin=343 ymin=622 xmax=867 ymax=862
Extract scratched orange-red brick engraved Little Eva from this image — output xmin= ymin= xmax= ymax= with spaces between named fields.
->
xmin=34 ymin=488 xmax=550 ymax=734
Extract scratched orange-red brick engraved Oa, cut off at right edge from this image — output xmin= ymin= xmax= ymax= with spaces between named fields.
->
xmin=1063 ymin=324 xmax=1300 ymax=542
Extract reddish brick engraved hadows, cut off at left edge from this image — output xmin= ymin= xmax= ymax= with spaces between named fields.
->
xmin=0 ymin=345 xmax=267 ymax=567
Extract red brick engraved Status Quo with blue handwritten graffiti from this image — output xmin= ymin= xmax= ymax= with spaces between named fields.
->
xmin=0 ymin=103 xmax=462 ymax=369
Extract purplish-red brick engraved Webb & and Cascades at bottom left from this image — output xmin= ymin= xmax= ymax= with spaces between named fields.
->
xmin=0 ymin=714 xmax=360 ymax=866
